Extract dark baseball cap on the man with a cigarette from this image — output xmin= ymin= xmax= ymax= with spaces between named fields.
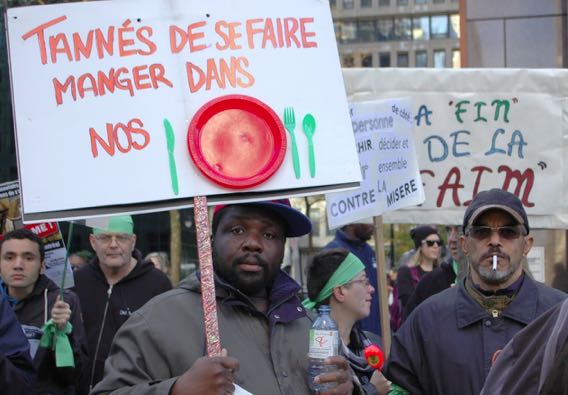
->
xmin=462 ymin=188 xmax=530 ymax=234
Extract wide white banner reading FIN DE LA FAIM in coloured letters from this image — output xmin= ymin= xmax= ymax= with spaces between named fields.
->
xmin=344 ymin=69 xmax=568 ymax=228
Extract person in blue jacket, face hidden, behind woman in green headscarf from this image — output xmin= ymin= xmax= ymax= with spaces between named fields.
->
xmin=324 ymin=223 xmax=381 ymax=336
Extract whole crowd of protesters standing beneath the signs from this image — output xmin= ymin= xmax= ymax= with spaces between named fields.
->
xmin=0 ymin=189 xmax=568 ymax=395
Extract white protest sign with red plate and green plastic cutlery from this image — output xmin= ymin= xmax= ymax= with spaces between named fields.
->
xmin=7 ymin=0 xmax=361 ymax=221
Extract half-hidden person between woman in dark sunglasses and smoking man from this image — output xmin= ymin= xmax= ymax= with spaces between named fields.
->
xmin=403 ymin=226 xmax=467 ymax=318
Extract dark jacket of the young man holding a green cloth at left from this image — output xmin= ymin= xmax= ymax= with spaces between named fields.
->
xmin=9 ymin=274 xmax=88 ymax=394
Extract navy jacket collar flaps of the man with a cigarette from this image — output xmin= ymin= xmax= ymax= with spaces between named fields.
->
xmin=455 ymin=275 xmax=538 ymax=329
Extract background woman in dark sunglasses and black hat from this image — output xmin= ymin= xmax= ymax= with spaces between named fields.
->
xmin=396 ymin=225 xmax=442 ymax=311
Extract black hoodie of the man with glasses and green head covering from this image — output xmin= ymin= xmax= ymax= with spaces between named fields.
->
xmin=74 ymin=250 xmax=172 ymax=386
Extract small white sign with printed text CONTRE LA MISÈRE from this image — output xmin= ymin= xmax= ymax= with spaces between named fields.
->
xmin=325 ymin=98 xmax=424 ymax=229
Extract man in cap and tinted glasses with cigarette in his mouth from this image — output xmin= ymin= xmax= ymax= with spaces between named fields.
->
xmin=385 ymin=189 xmax=565 ymax=395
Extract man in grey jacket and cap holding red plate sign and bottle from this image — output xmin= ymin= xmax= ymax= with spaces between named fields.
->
xmin=91 ymin=200 xmax=353 ymax=395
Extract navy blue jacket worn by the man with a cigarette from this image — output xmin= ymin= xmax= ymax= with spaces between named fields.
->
xmin=384 ymin=276 xmax=566 ymax=395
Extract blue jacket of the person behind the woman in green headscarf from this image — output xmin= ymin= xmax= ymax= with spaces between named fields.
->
xmin=325 ymin=229 xmax=381 ymax=336
